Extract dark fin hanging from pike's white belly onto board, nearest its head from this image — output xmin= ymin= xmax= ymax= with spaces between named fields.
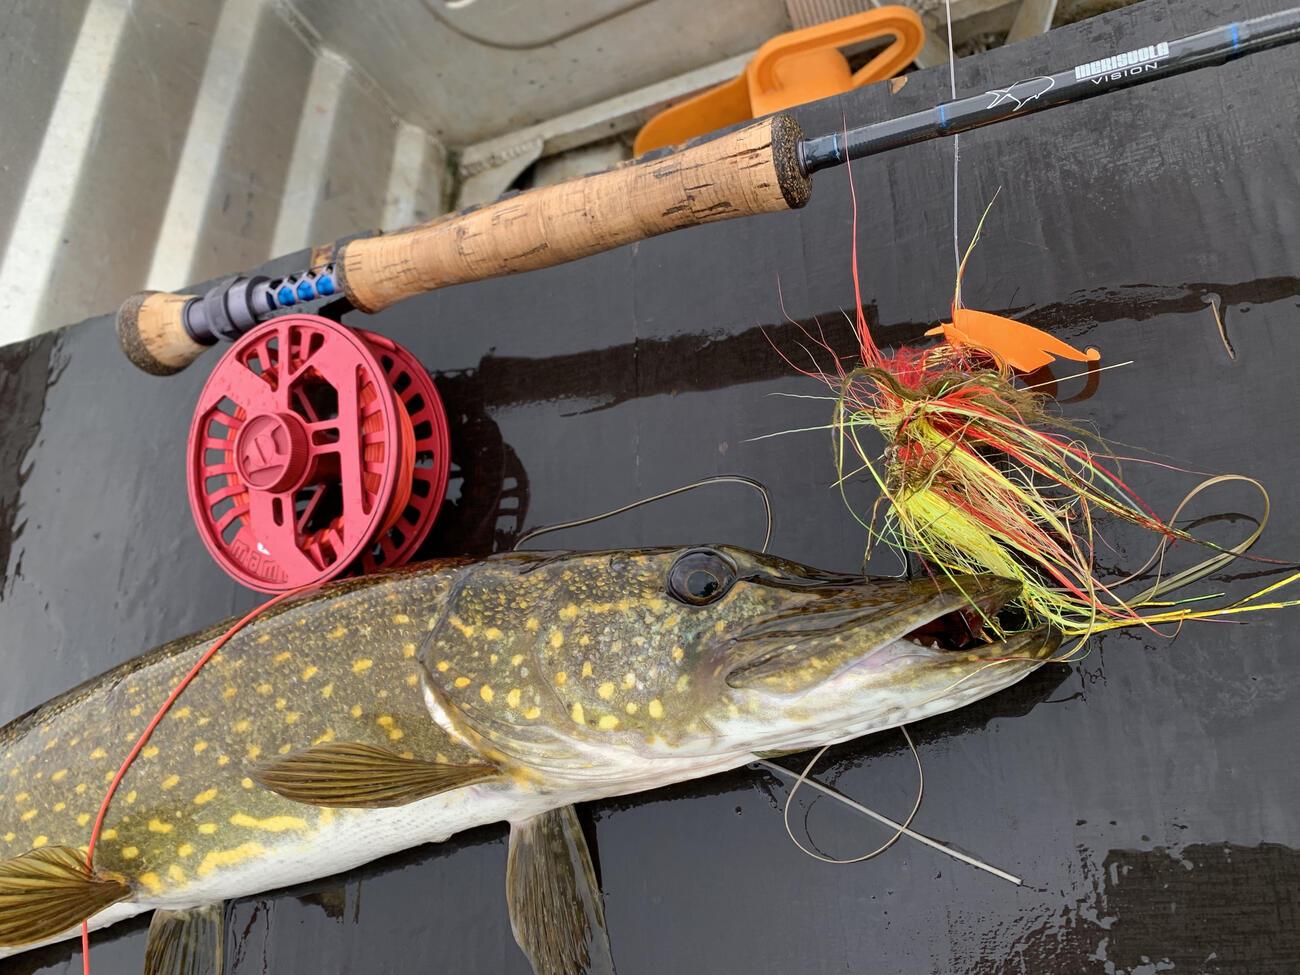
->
xmin=506 ymin=806 xmax=614 ymax=975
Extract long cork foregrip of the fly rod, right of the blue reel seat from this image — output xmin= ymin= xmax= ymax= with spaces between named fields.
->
xmin=337 ymin=116 xmax=813 ymax=312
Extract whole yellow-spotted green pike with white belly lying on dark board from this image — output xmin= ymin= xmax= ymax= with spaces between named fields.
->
xmin=0 ymin=546 xmax=1058 ymax=975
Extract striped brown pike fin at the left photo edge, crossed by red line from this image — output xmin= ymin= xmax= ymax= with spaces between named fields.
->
xmin=0 ymin=846 xmax=131 ymax=948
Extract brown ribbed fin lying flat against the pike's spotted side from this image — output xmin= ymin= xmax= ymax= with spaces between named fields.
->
xmin=248 ymin=741 xmax=501 ymax=809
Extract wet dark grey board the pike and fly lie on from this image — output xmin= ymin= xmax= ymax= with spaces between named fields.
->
xmin=0 ymin=0 xmax=1300 ymax=975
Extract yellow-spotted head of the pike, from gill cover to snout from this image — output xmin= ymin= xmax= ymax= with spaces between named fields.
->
xmin=421 ymin=546 xmax=1058 ymax=780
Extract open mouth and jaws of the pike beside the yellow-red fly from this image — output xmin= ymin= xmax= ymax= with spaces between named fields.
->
xmin=727 ymin=576 xmax=1061 ymax=690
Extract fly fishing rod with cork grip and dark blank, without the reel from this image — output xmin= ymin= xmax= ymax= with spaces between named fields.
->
xmin=117 ymin=8 xmax=1300 ymax=376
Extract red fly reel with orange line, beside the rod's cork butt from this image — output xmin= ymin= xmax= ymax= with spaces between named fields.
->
xmin=187 ymin=315 xmax=451 ymax=593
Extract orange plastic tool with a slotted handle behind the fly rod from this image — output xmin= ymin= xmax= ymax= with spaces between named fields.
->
xmin=633 ymin=7 xmax=926 ymax=156
